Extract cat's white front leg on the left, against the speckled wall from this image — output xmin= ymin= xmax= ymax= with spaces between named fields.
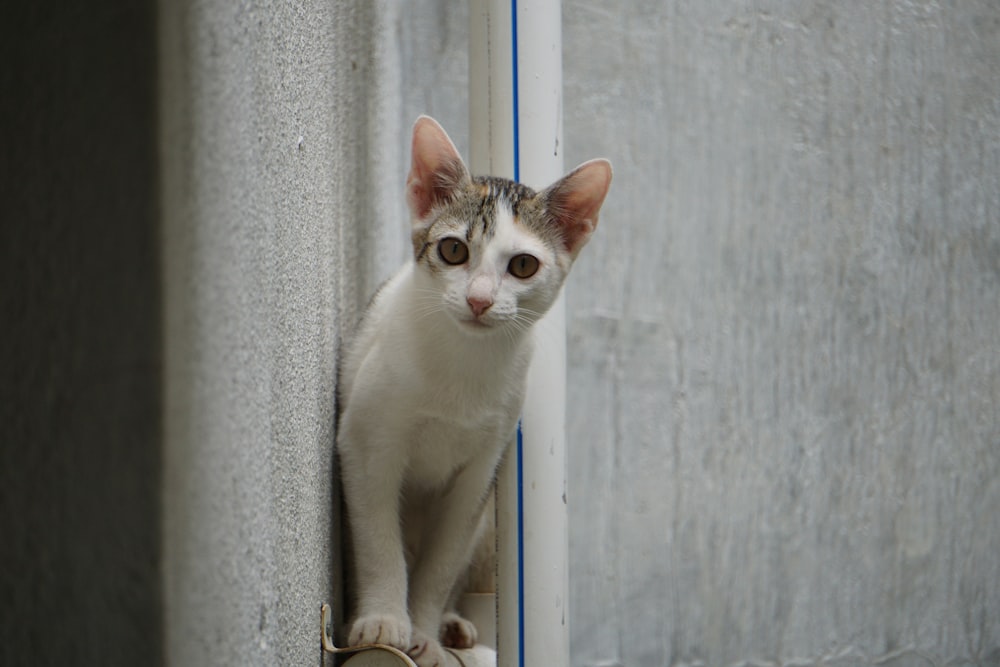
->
xmin=338 ymin=420 xmax=412 ymax=651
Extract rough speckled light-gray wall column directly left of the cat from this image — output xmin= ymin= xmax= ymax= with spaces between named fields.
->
xmin=160 ymin=0 xmax=371 ymax=667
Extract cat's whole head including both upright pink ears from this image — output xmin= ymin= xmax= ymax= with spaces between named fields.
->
xmin=406 ymin=116 xmax=611 ymax=336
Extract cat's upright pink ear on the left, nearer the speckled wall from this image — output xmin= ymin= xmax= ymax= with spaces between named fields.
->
xmin=406 ymin=116 xmax=471 ymax=220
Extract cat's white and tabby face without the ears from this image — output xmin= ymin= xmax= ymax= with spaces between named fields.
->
xmin=413 ymin=178 xmax=572 ymax=334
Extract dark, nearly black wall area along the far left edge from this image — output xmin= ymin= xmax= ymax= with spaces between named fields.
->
xmin=0 ymin=0 xmax=163 ymax=667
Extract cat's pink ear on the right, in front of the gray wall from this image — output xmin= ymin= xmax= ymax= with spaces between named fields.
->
xmin=542 ymin=158 xmax=612 ymax=258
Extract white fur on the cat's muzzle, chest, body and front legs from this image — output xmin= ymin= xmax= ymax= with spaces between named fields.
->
xmin=338 ymin=216 xmax=562 ymax=664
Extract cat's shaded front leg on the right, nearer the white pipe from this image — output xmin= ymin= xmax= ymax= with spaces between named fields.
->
xmin=410 ymin=457 xmax=496 ymax=667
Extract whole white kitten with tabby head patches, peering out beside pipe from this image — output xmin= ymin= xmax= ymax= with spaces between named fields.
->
xmin=337 ymin=116 xmax=612 ymax=667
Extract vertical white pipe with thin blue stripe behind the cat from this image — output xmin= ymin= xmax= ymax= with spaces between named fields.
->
xmin=469 ymin=0 xmax=569 ymax=667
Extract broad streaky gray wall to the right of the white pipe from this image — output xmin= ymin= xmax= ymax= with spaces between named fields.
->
xmin=564 ymin=0 xmax=1000 ymax=665
